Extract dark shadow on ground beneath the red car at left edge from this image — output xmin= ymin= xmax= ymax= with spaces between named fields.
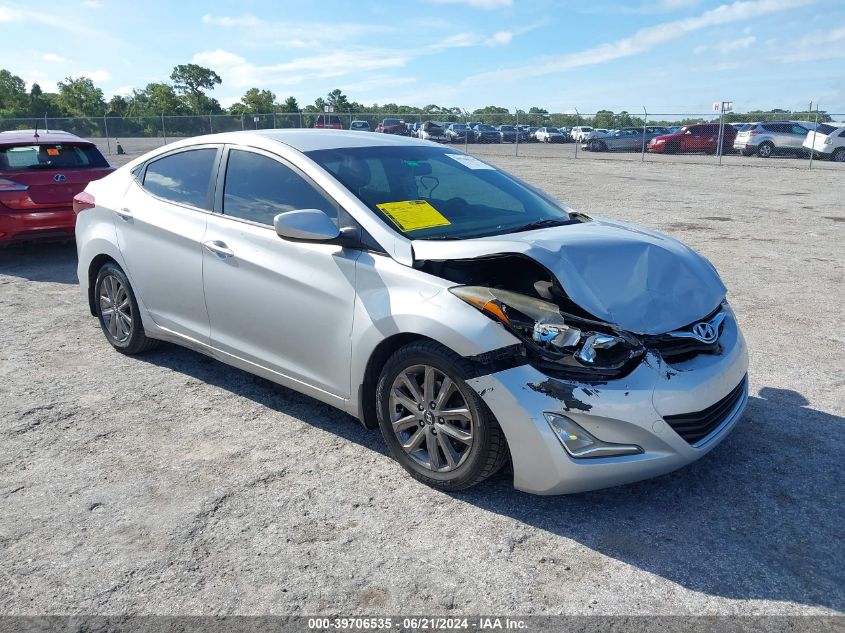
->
xmin=0 ymin=241 xmax=78 ymax=284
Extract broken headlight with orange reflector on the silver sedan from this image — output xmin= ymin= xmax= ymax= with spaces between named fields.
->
xmin=449 ymin=286 xmax=643 ymax=378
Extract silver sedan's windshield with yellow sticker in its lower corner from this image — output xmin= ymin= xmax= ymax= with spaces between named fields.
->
xmin=306 ymin=146 xmax=578 ymax=239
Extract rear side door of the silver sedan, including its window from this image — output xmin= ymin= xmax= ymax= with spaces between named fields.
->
xmin=114 ymin=145 xmax=221 ymax=344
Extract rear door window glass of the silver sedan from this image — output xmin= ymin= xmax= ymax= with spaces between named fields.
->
xmin=144 ymin=148 xmax=217 ymax=209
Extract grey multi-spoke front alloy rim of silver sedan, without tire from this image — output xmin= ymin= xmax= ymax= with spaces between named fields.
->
xmin=390 ymin=365 xmax=476 ymax=473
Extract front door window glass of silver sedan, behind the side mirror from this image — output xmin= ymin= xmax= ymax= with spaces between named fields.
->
xmin=223 ymin=149 xmax=337 ymax=226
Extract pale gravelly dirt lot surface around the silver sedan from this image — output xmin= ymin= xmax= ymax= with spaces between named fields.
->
xmin=0 ymin=147 xmax=845 ymax=614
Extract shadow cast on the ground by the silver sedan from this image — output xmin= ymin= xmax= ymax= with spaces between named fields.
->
xmin=143 ymin=346 xmax=845 ymax=610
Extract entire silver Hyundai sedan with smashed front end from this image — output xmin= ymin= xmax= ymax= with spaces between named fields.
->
xmin=74 ymin=130 xmax=748 ymax=494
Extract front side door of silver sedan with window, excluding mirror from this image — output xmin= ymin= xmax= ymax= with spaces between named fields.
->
xmin=203 ymin=147 xmax=361 ymax=398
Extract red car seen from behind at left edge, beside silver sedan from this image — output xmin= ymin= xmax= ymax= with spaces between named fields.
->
xmin=0 ymin=130 xmax=114 ymax=245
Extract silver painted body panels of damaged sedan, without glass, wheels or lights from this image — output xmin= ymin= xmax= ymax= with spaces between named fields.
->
xmin=77 ymin=130 xmax=748 ymax=494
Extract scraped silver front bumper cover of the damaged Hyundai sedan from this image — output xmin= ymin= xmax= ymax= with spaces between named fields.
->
xmin=467 ymin=314 xmax=748 ymax=495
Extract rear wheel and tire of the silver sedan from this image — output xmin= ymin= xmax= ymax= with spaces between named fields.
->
xmin=94 ymin=263 xmax=158 ymax=355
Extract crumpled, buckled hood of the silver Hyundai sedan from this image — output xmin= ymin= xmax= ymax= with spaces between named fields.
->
xmin=413 ymin=218 xmax=726 ymax=334
